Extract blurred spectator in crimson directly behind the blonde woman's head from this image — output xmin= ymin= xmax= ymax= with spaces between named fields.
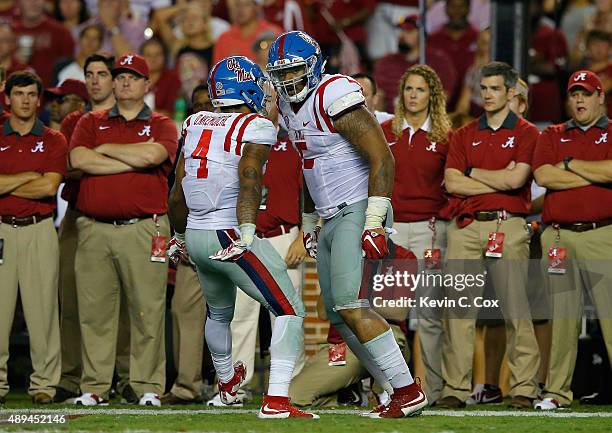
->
xmin=374 ymin=15 xmax=457 ymax=112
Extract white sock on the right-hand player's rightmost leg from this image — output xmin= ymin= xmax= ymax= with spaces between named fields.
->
xmin=363 ymin=329 xmax=414 ymax=388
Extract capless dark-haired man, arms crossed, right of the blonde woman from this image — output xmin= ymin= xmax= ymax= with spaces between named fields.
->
xmin=438 ymin=62 xmax=539 ymax=408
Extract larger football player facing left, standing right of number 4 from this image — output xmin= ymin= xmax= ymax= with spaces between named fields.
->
xmin=266 ymin=31 xmax=427 ymax=418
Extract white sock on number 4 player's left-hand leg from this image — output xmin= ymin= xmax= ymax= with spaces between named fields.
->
xmin=204 ymin=317 xmax=234 ymax=383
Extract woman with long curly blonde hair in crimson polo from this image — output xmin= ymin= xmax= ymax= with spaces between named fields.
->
xmin=382 ymin=65 xmax=451 ymax=402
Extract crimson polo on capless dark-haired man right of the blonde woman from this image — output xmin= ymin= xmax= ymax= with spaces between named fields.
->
xmin=446 ymin=112 xmax=540 ymax=216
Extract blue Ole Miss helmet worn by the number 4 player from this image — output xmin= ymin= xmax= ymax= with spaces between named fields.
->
xmin=208 ymin=56 xmax=266 ymax=114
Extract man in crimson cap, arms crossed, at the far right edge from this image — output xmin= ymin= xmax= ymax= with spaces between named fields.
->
xmin=533 ymin=70 xmax=612 ymax=410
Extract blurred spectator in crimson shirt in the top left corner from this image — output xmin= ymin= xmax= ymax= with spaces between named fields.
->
xmin=15 ymin=0 xmax=74 ymax=87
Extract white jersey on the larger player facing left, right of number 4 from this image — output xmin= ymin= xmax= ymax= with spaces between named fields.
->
xmin=278 ymin=75 xmax=370 ymax=219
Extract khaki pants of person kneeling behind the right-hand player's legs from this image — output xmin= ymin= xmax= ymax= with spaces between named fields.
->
xmin=289 ymin=325 xmax=410 ymax=406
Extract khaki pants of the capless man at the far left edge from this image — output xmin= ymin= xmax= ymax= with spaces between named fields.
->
xmin=0 ymin=218 xmax=61 ymax=397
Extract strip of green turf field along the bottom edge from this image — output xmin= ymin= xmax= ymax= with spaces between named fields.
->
xmin=0 ymin=395 xmax=612 ymax=433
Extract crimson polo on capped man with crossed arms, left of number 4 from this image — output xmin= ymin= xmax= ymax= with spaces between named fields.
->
xmin=70 ymin=104 xmax=178 ymax=219
